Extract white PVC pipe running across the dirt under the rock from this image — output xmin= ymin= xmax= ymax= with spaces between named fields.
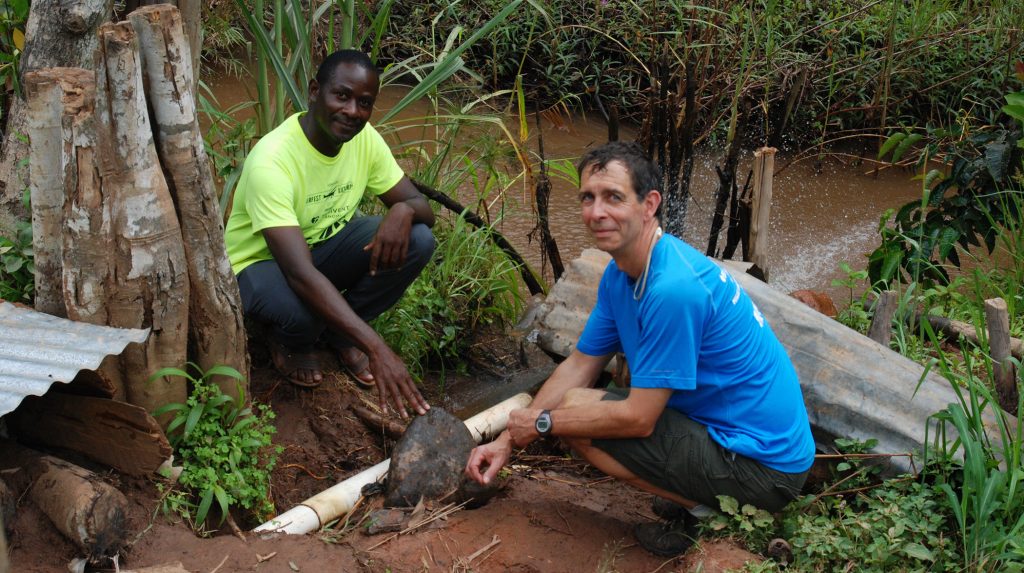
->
xmin=253 ymin=394 xmax=531 ymax=534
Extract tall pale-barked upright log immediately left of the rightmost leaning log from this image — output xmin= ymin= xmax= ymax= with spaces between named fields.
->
xmin=96 ymin=21 xmax=188 ymax=424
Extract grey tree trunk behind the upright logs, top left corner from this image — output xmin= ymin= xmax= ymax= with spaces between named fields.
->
xmin=0 ymin=0 xmax=113 ymax=216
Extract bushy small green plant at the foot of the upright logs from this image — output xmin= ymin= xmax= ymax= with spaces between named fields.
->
xmin=150 ymin=362 xmax=281 ymax=531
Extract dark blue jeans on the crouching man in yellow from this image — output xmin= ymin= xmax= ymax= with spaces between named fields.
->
xmin=238 ymin=217 xmax=434 ymax=351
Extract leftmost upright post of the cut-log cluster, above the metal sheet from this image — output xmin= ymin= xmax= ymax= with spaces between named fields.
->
xmin=25 ymin=68 xmax=96 ymax=317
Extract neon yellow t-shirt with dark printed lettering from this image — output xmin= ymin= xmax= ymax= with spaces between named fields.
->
xmin=224 ymin=114 xmax=404 ymax=274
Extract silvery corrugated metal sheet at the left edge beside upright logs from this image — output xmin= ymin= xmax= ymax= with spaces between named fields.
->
xmin=0 ymin=302 xmax=150 ymax=415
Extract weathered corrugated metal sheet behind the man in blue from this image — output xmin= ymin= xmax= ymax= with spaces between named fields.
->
xmin=530 ymin=249 xmax=1016 ymax=471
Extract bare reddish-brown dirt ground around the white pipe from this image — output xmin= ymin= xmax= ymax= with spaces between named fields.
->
xmin=2 ymin=335 xmax=755 ymax=573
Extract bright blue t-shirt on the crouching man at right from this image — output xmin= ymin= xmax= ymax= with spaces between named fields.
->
xmin=577 ymin=234 xmax=814 ymax=474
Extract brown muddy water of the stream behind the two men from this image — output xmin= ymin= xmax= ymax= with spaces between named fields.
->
xmin=203 ymin=78 xmax=921 ymax=303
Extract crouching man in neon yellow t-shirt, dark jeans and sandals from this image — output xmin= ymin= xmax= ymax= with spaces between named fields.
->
xmin=225 ymin=50 xmax=434 ymax=416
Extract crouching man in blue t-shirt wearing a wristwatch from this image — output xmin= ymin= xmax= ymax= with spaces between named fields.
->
xmin=466 ymin=142 xmax=814 ymax=556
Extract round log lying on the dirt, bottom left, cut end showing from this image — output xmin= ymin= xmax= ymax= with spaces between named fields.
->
xmin=0 ymin=443 xmax=128 ymax=560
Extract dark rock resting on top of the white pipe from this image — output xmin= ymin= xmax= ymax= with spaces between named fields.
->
xmin=384 ymin=407 xmax=497 ymax=508
